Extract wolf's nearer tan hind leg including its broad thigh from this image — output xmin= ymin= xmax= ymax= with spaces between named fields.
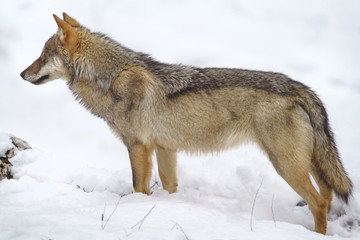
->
xmin=257 ymin=108 xmax=329 ymax=234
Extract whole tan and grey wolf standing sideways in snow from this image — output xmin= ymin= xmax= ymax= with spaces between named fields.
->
xmin=20 ymin=13 xmax=352 ymax=234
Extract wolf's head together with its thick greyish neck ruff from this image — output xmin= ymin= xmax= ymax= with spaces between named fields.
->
xmin=20 ymin=13 xmax=129 ymax=91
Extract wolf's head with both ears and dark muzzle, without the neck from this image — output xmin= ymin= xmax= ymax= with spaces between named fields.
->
xmin=20 ymin=13 xmax=81 ymax=85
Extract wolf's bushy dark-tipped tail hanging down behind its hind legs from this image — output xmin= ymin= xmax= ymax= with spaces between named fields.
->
xmin=297 ymin=85 xmax=352 ymax=203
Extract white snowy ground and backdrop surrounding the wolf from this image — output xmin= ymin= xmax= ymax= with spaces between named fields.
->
xmin=0 ymin=0 xmax=360 ymax=240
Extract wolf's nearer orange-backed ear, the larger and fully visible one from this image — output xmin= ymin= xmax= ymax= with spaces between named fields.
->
xmin=53 ymin=14 xmax=79 ymax=53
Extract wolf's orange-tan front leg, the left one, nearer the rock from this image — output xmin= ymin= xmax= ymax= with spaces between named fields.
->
xmin=128 ymin=144 xmax=153 ymax=195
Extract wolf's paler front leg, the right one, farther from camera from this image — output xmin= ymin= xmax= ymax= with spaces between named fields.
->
xmin=156 ymin=147 xmax=178 ymax=193
